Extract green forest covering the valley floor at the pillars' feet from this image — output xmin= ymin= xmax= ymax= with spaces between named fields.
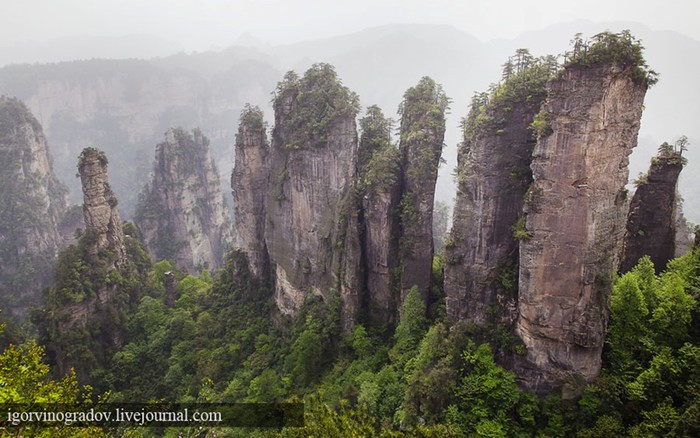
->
xmin=0 ymin=240 xmax=700 ymax=437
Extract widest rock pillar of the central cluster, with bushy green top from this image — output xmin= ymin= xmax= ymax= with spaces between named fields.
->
xmin=265 ymin=64 xmax=358 ymax=315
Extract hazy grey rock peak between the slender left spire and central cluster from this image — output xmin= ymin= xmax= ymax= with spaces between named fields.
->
xmin=135 ymin=129 xmax=232 ymax=273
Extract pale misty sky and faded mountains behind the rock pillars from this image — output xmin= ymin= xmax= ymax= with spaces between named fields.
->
xmin=0 ymin=0 xmax=700 ymax=223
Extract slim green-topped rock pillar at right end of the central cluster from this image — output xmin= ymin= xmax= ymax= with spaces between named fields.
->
xmin=399 ymin=77 xmax=449 ymax=299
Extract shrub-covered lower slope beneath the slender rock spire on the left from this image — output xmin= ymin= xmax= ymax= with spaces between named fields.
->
xmin=32 ymin=223 xmax=151 ymax=390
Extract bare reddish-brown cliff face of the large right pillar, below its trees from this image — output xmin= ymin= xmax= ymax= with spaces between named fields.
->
xmin=516 ymin=60 xmax=648 ymax=392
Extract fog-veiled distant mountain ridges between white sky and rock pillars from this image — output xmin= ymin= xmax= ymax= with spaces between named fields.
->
xmin=0 ymin=20 xmax=700 ymax=222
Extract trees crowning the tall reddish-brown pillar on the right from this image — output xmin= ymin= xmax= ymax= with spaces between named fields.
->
xmin=564 ymin=30 xmax=659 ymax=86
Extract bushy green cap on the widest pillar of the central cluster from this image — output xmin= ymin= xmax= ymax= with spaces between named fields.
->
xmin=273 ymin=63 xmax=360 ymax=149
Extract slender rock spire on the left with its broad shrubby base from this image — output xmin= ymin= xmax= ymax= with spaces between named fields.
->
xmin=38 ymin=147 xmax=151 ymax=380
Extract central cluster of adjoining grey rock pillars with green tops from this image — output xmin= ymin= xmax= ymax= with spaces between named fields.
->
xmin=232 ymin=64 xmax=448 ymax=331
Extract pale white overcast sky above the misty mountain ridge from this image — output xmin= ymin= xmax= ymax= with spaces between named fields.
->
xmin=5 ymin=0 xmax=700 ymax=51
